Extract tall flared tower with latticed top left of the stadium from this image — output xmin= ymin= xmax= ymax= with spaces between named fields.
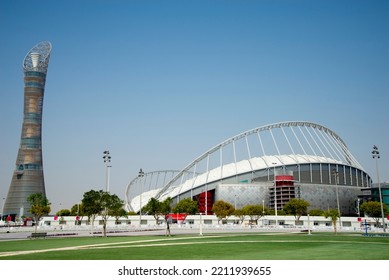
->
xmin=3 ymin=42 xmax=51 ymax=217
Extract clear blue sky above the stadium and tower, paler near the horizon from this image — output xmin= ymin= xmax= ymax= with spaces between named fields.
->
xmin=0 ymin=0 xmax=389 ymax=212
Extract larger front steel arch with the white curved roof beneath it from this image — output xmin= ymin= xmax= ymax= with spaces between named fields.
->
xmin=155 ymin=121 xmax=364 ymax=199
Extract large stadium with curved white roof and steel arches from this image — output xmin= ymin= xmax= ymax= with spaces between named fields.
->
xmin=125 ymin=121 xmax=371 ymax=216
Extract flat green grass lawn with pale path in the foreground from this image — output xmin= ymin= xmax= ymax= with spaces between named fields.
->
xmin=0 ymin=233 xmax=389 ymax=260
